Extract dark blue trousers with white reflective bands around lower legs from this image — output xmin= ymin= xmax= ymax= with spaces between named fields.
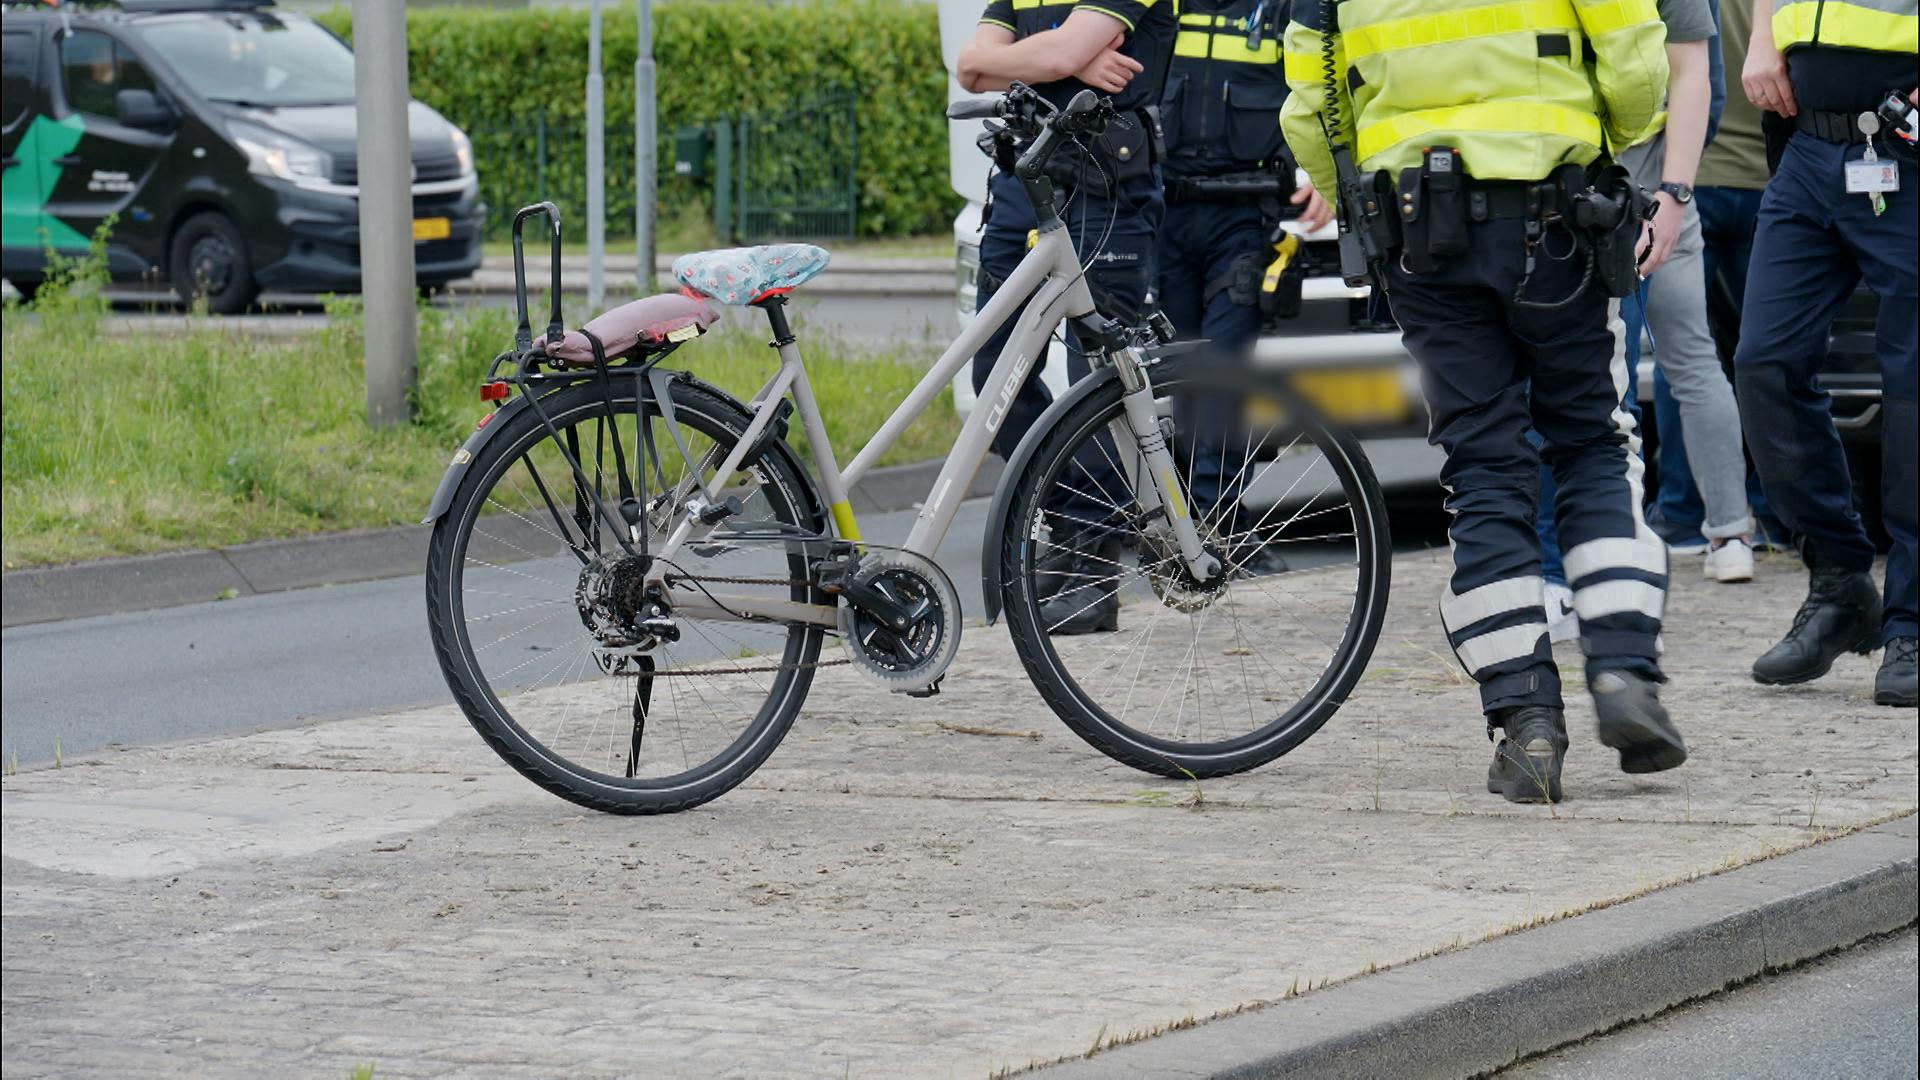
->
xmin=1386 ymin=219 xmax=1667 ymax=713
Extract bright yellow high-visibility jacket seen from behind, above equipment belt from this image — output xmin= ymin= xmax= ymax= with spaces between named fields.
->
xmin=1281 ymin=0 xmax=1674 ymax=196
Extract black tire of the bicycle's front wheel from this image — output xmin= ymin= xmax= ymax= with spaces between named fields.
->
xmin=998 ymin=359 xmax=1392 ymax=778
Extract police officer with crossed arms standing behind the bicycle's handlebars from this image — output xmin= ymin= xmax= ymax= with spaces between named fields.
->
xmin=956 ymin=0 xmax=1175 ymax=634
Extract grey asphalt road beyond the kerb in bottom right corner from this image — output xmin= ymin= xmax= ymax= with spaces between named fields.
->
xmin=1500 ymin=928 xmax=1920 ymax=1080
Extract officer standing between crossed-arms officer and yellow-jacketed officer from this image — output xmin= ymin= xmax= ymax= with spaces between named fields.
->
xmin=1156 ymin=0 xmax=1332 ymax=557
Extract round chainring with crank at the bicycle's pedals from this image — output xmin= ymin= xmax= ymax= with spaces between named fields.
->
xmin=839 ymin=548 xmax=960 ymax=694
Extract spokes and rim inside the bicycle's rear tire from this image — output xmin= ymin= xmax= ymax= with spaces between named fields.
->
xmin=436 ymin=379 xmax=824 ymax=799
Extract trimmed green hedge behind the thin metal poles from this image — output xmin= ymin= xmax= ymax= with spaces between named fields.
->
xmin=321 ymin=0 xmax=958 ymax=238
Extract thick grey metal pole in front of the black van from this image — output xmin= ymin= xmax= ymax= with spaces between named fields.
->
xmin=353 ymin=0 xmax=417 ymax=427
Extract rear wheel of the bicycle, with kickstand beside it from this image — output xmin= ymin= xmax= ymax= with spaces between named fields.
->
xmin=426 ymin=373 xmax=826 ymax=813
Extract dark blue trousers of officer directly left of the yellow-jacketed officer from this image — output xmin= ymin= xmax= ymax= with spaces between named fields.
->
xmin=1156 ymin=202 xmax=1273 ymax=517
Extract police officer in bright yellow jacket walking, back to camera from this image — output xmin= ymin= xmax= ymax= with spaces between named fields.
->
xmin=1283 ymin=0 xmax=1686 ymax=801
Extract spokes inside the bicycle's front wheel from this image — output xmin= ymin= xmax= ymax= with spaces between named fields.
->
xmin=1014 ymin=369 xmax=1377 ymax=774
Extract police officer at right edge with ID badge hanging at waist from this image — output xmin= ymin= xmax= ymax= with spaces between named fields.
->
xmin=1734 ymin=0 xmax=1920 ymax=709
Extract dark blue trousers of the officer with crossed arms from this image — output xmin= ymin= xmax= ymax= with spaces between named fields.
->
xmin=973 ymin=171 xmax=1164 ymax=525
